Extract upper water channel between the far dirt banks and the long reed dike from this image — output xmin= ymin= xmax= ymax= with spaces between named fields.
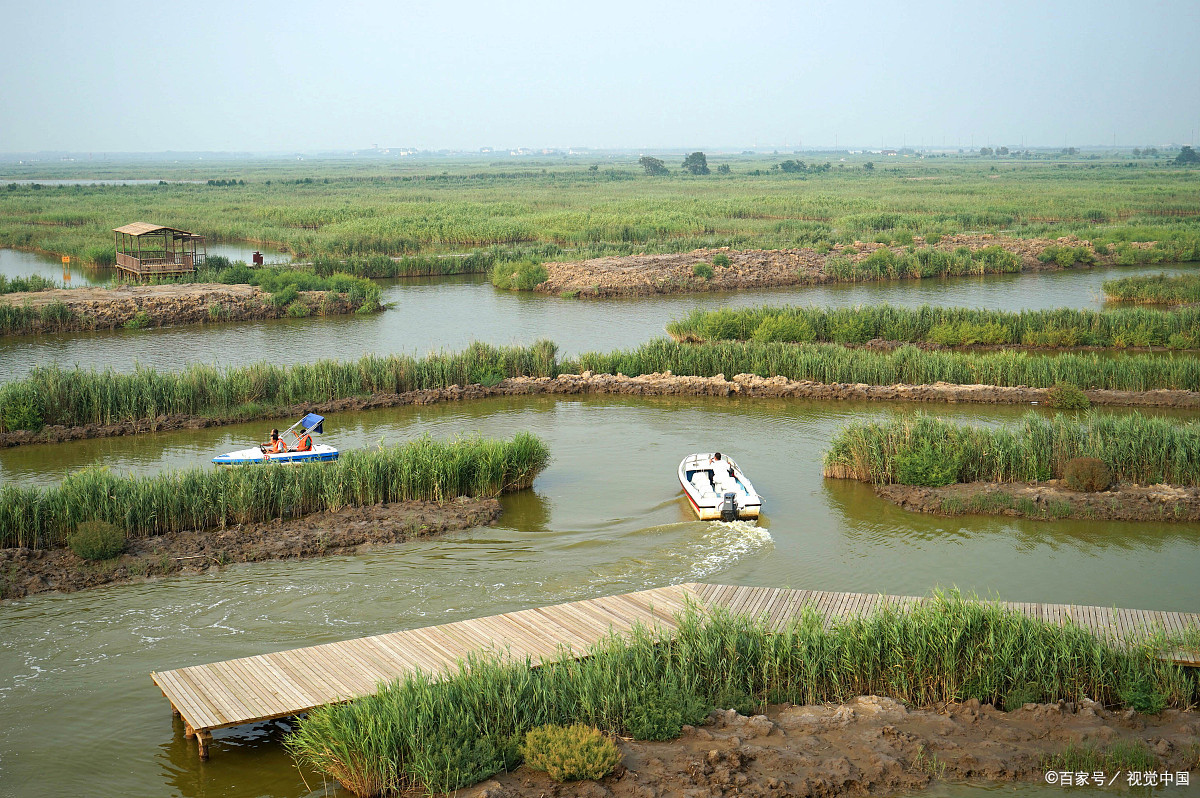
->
xmin=0 ymin=261 xmax=1194 ymax=382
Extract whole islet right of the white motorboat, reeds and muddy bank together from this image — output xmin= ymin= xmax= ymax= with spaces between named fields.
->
xmin=823 ymin=413 xmax=1200 ymax=522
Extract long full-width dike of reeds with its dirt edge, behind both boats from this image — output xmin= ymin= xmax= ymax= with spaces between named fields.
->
xmin=0 ymin=340 xmax=1200 ymax=446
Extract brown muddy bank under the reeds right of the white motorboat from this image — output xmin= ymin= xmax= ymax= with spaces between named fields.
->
xmin=875 ymin=480 xmax=1200 ymax=522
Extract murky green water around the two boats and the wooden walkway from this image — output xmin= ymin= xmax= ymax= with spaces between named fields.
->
xmin=0 ymin=397 xmax=1200 ymax=797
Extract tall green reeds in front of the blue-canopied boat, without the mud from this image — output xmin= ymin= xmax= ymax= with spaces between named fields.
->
xmin=0 ymin=432 xmax=550 ymax=548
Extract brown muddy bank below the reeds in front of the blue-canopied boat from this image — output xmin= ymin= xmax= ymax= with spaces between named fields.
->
xmin=0 ymin=497 xmax=500 ymax=599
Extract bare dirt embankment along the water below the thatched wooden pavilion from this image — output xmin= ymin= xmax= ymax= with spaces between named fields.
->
xmin=0 ymin=283 xmax=361 ymax=334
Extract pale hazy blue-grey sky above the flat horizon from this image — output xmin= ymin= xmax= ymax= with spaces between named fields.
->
xmin=0 ymin=0 xmax=1200 ymax=152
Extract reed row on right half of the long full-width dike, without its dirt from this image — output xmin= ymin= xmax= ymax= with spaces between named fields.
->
xmin=560 ymin=340 xmax=1200 ymax=391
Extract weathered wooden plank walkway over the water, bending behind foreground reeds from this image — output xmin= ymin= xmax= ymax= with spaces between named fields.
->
xmin=150 ymin=583 xmax=1200 ymax=757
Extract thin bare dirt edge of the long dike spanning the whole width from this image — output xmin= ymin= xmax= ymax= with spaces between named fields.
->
xmin=0 ymin=371 xmax=1200 ymax=448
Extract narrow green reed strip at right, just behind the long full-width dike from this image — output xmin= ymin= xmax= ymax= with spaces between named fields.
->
xmin=667 ymin=302 xmax=1200 ymax=349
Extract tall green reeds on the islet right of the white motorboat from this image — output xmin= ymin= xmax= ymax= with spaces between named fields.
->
xmin=824 ymin=413 xmax=1200 ymax=487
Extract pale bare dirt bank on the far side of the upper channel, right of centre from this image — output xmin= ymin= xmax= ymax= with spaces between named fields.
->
xmin=535 ymin=235 xmax=1115 ymax=299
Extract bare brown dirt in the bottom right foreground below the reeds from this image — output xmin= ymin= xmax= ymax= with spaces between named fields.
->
xmin=466 ymin=696 xmax=1200 ymax=798
